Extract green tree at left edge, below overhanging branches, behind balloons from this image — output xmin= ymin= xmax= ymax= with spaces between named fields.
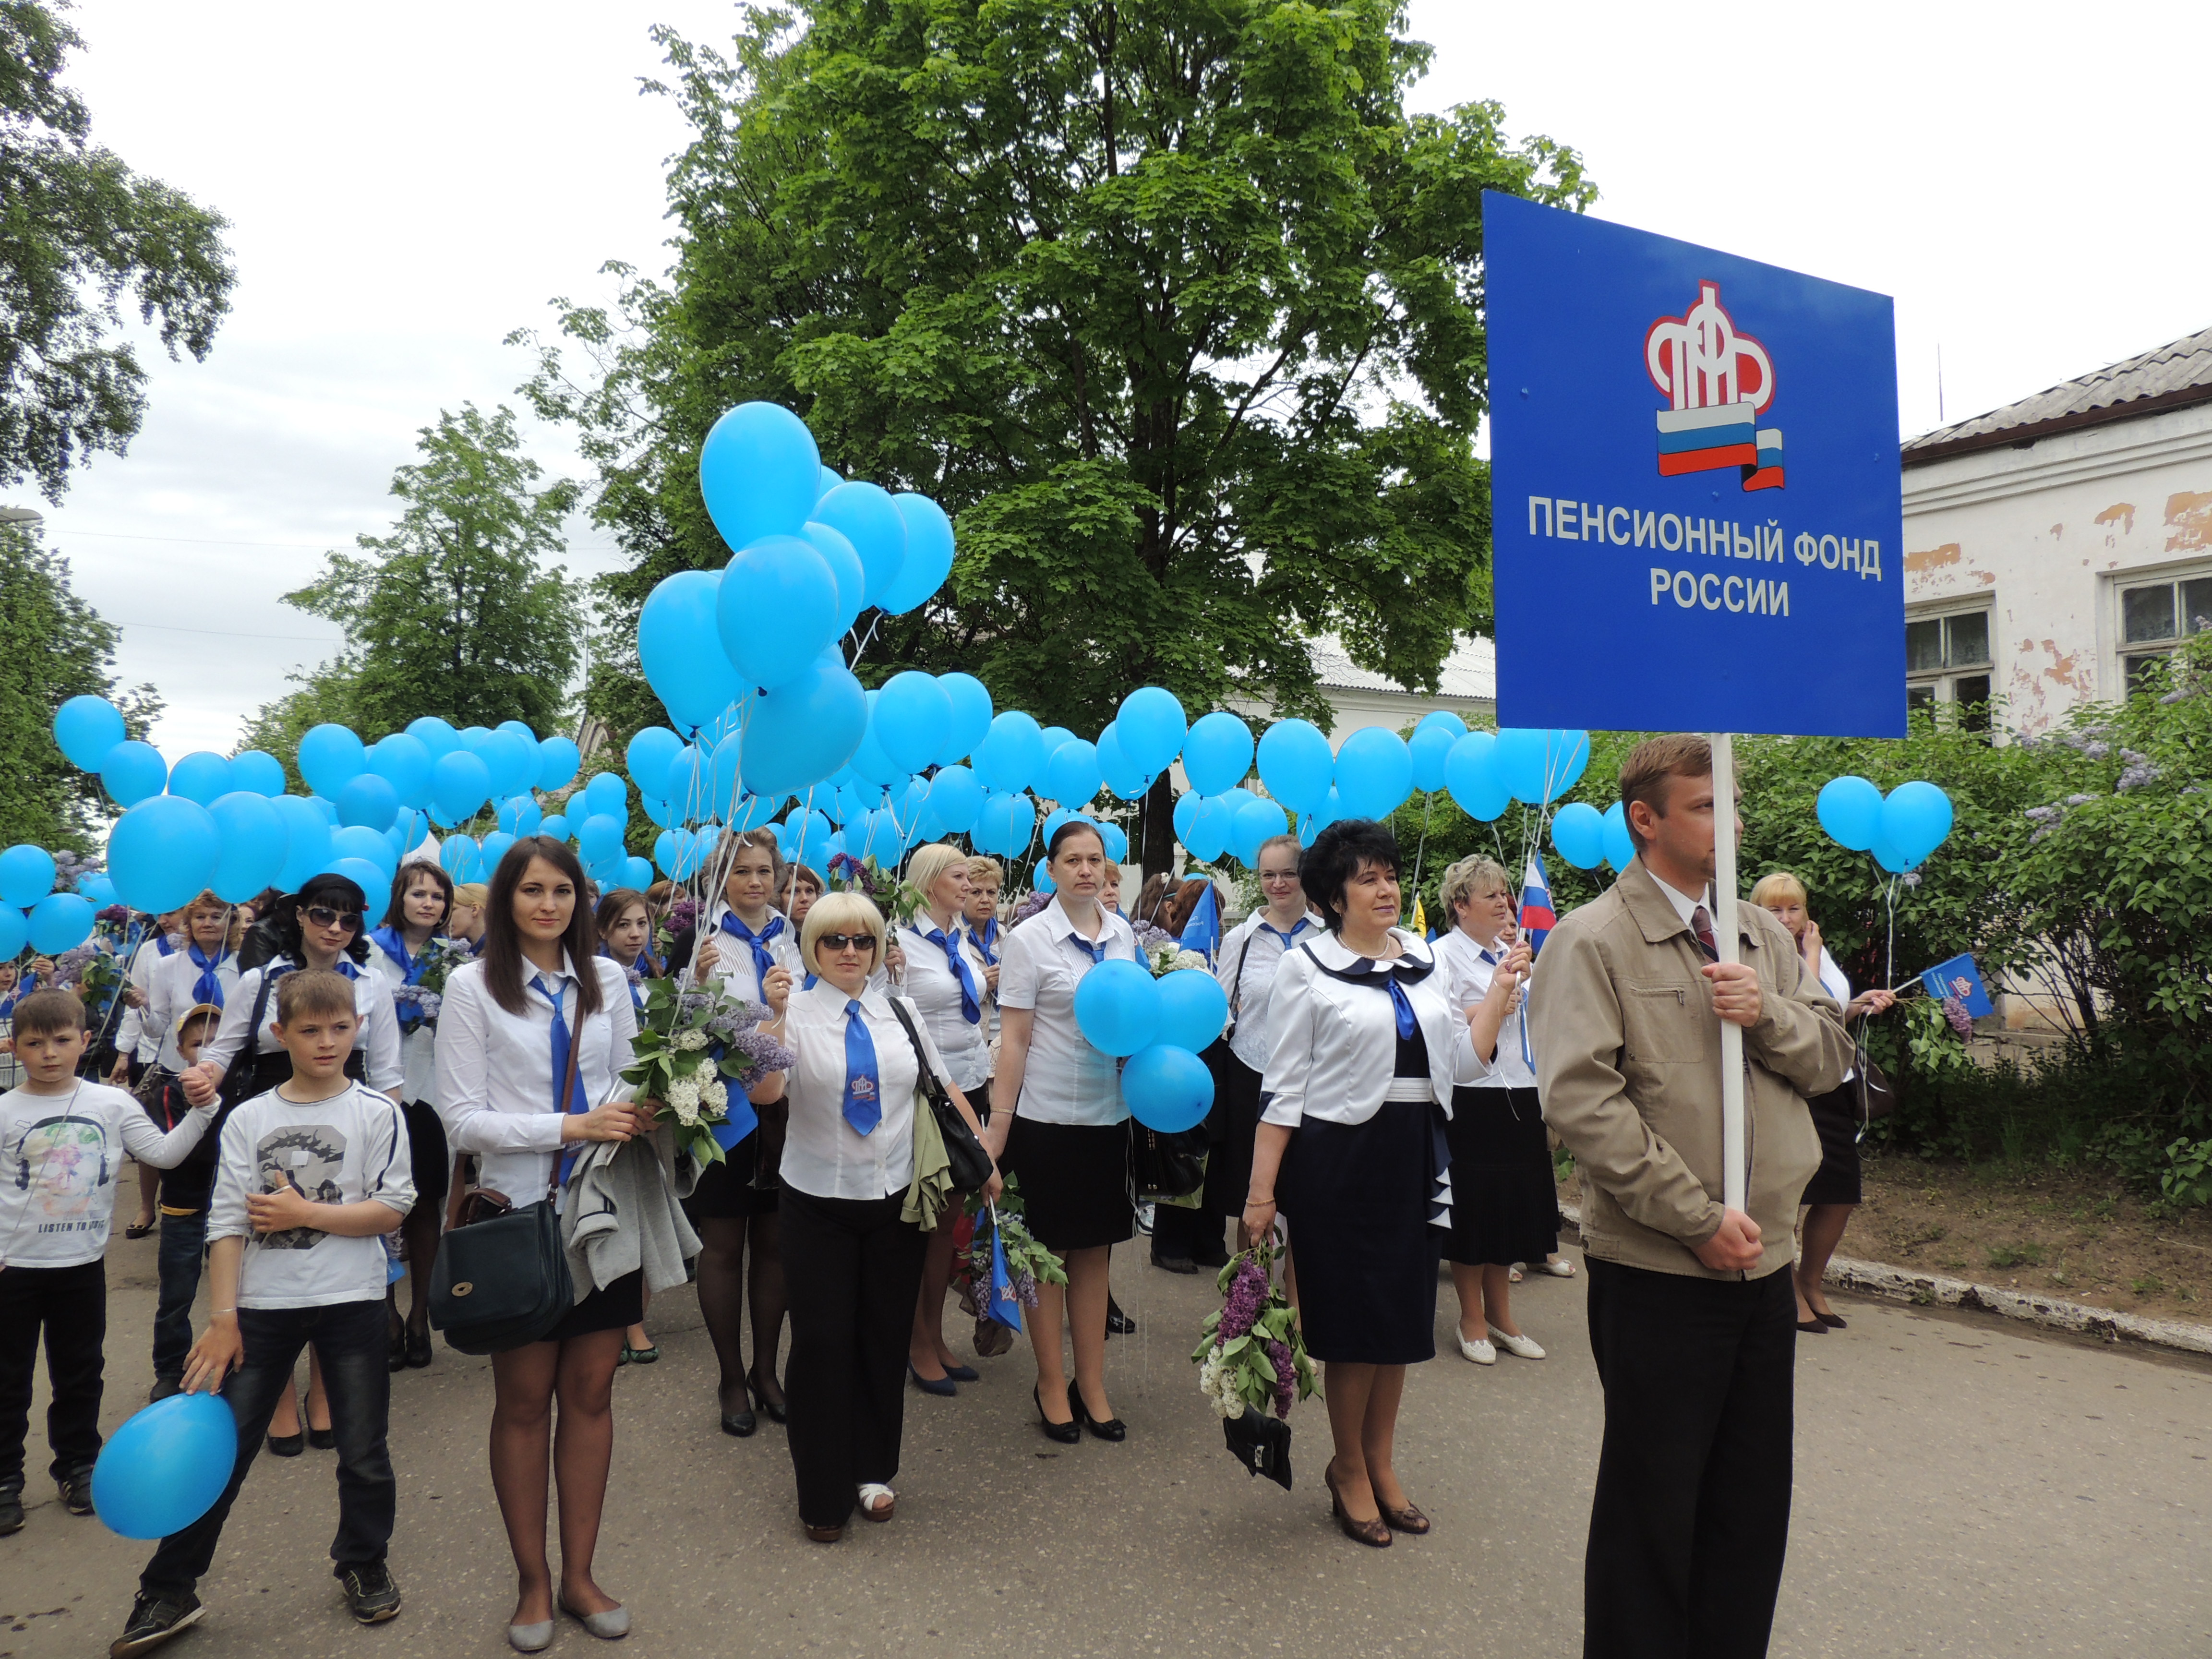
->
xmin=0 ymin=524 xmax=161 ymax=852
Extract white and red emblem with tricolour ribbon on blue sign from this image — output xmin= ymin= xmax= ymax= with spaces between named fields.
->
xmin=1644 ymin=281 xmax=1783 ymax=489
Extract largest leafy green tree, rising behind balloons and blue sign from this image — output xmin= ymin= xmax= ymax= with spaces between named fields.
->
xmin=517 ymin=0 xmax=1593 ymax=867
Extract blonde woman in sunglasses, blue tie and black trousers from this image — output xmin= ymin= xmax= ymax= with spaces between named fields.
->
xmin=754 ymin=894 xmax=998 ymax=1544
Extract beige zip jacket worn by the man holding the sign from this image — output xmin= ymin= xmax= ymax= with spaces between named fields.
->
xmin=1528 ymin=858 xmax=1851 ymax=1278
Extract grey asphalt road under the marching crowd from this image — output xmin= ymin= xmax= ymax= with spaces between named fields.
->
xmin=0 ymin=1230 xmax=2212 ymax=1659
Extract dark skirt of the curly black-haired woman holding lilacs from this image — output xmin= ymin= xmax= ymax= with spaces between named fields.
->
xmin=1276 ymin=1099 xmax=1458 ymax=1365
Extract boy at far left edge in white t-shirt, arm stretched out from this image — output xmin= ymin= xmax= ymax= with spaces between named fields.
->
xmin=0 ymin=991 xmax=215 ymax=1535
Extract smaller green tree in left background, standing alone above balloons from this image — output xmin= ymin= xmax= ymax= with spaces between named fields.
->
xmin=241 ymin=405 xmax=584 ymax=765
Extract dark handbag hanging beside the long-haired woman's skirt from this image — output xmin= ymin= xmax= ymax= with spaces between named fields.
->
xmin=429 ymin=1026 xmax=584 ymax=1354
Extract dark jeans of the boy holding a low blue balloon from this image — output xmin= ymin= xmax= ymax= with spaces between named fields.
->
xmin=139 ymin=1296 xmax=398 ymax=1595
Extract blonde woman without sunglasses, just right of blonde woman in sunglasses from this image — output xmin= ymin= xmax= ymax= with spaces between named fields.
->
xmin=900 ymin=841 xmax=998 ymax=1394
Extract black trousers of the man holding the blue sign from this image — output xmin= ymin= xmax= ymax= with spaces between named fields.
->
xmin=1582 ymin=1259 xmax=1796 ymax=1659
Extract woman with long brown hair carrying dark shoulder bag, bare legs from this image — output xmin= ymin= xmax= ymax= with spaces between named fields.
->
xmin=438 ymin=836 xmax=646 ymax=1652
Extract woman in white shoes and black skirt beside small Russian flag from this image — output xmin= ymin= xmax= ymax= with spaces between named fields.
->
xmin=1436 ymin=856 xmax=1573 ymax=1365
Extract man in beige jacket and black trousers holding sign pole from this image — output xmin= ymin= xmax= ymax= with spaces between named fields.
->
xmin=1528 ymin=734 xmax=1851 ymax=1659
